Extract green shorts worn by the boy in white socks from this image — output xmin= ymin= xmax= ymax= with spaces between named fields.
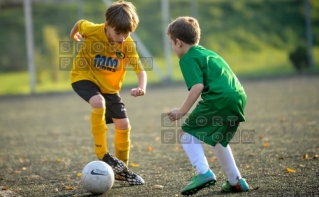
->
xmin=182 ymin=94 xmax=246 ymax=147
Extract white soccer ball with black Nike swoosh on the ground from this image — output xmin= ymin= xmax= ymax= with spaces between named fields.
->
xmin=81 ymin=161 xmax=114 ymax=194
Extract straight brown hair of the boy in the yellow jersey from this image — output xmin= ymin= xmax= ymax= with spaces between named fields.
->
xmin=105 ymin=1 xmax=139 ymax=33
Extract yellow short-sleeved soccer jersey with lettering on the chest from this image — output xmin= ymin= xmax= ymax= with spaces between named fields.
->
xmin=71 ymin=20 xmax=143 ymax=94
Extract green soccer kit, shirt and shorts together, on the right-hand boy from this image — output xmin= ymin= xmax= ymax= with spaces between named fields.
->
xmin=179 ymin=45 xmax=247 ymax=146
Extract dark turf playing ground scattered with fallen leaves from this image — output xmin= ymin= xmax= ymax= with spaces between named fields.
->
xmin=0 ymin=75 xmax=319 ymax=197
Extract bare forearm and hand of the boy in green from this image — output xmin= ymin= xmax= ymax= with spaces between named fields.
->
xmin=167 ymin=83 xmax=204 ymax=121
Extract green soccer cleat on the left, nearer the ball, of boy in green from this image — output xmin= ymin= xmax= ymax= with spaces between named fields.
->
xmin=181 ymin=170 xmax=216 ymax=195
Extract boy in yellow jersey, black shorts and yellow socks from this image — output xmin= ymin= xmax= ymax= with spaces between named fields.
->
xmin=70 ymin=1 xmax=147 ymax=185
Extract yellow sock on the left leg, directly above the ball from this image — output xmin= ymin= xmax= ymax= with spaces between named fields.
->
xmin=91 ymin=108 xmax=108 ymax=159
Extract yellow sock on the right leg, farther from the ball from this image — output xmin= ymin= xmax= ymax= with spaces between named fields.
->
xmin=114 ymin=126 xmax=131 ymax=165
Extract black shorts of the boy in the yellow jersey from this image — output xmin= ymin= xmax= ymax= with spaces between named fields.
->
xmin=72 ymin=80 xmax=127 ymax=124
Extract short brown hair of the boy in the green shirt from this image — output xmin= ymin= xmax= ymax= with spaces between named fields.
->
xmin=167 ymin=16 xmax=200 ymax=44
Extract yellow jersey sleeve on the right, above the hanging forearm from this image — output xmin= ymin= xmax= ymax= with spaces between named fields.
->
xmin=125 ymin=37 xmax=144 ymax=74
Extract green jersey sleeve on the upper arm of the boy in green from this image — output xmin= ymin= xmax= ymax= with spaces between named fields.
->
xmin=179 ymin=58 xmax=204 ymax=90
